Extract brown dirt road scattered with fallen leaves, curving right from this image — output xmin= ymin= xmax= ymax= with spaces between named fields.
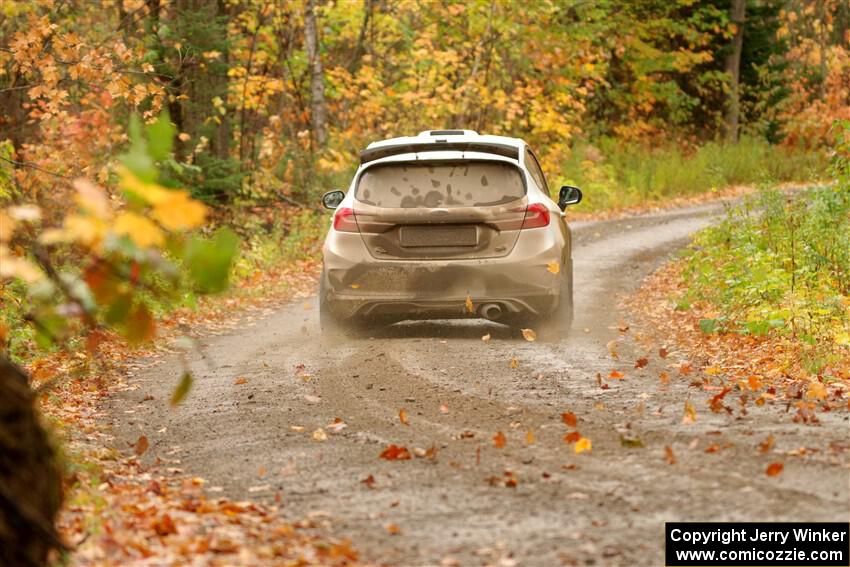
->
xmin=110 ymin=207 xmax=850 ymax=566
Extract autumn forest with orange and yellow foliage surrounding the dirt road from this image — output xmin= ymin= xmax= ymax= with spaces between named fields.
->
xmin=0 ymin=0 xmax=850 ymax=565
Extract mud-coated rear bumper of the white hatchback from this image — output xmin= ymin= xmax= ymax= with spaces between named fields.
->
xmin=323 ymin=231 xmax=572 ymax=319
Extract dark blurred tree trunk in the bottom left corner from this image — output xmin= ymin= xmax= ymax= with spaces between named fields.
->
xmin=0 ymin=356 xmax=64 ymax=567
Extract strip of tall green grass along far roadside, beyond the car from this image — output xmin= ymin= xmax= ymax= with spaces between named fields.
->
xmin=561 ymin=137 xmax=829 ymax=211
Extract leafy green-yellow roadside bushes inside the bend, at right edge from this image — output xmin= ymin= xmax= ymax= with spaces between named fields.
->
xmin=678 ymin=123 xmax=850 ymax=381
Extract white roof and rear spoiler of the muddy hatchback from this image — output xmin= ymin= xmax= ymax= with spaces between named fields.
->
xmin=360 ymin=130 xmax=525 ymax=163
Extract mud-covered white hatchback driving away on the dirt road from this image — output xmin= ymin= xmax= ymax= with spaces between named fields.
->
xmin=320 ymin=131 xmax=572 ymax=336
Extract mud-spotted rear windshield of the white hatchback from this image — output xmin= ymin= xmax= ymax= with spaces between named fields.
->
xmin=355 ymin=161 xmax=525 ymax=208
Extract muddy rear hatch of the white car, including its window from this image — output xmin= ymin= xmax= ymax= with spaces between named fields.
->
xmin=353 ymin=160 xmax=528 ymax=260
